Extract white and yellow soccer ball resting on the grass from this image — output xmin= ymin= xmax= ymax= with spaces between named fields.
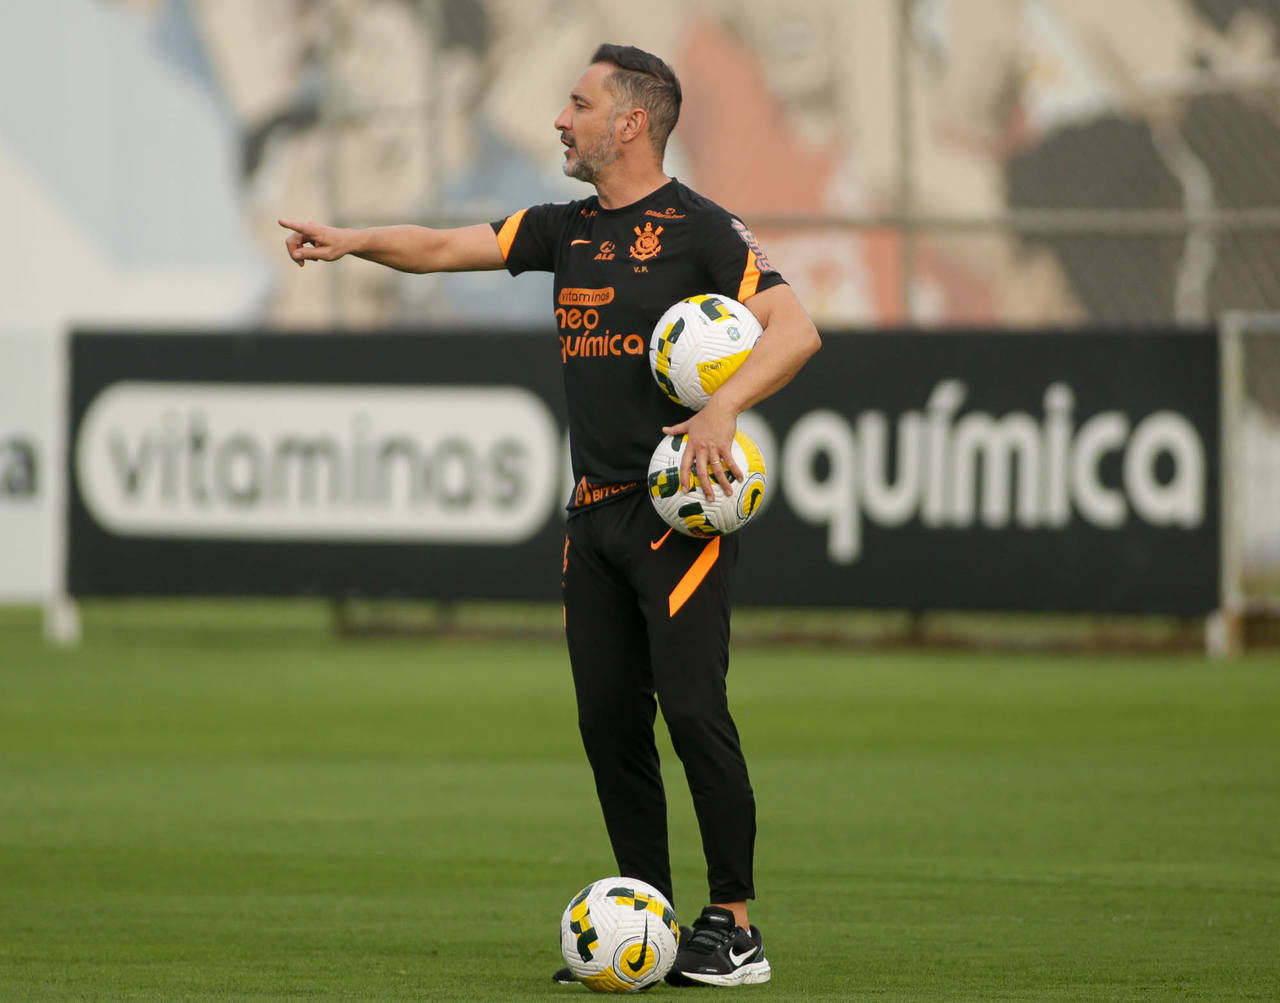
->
xmin=561 ymin=878 xmax=680 ymax=993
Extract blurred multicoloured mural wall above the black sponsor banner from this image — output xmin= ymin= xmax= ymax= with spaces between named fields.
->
xmin=0 ymin=0 xmax=1280 ymax=328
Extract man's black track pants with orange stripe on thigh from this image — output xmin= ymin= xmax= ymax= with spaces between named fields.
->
xmin=563 ymin=490 xmax=755 ymax=902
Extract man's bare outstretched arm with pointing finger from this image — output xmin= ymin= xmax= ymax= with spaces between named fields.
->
xmin=278 ymin=220 xmax=504 ymax=272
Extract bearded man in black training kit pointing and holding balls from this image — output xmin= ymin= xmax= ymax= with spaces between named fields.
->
xmin=280 ymin=45 xmax=819 ymax=985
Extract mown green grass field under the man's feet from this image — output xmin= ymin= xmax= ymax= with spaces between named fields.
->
xmin=0 ymin=604 xmax=1280 ymax=1002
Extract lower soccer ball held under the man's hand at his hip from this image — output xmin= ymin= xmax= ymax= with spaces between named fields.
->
xmin=649 ymin=431 xmax=768 ymax=537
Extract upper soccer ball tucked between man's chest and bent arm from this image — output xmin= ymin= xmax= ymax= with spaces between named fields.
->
xmin=649 ymin=293 xmax=763 ymax=411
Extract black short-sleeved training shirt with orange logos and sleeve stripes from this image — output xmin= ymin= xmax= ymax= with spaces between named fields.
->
xmin=493 ymin=179 xmax=783 ymax=484
